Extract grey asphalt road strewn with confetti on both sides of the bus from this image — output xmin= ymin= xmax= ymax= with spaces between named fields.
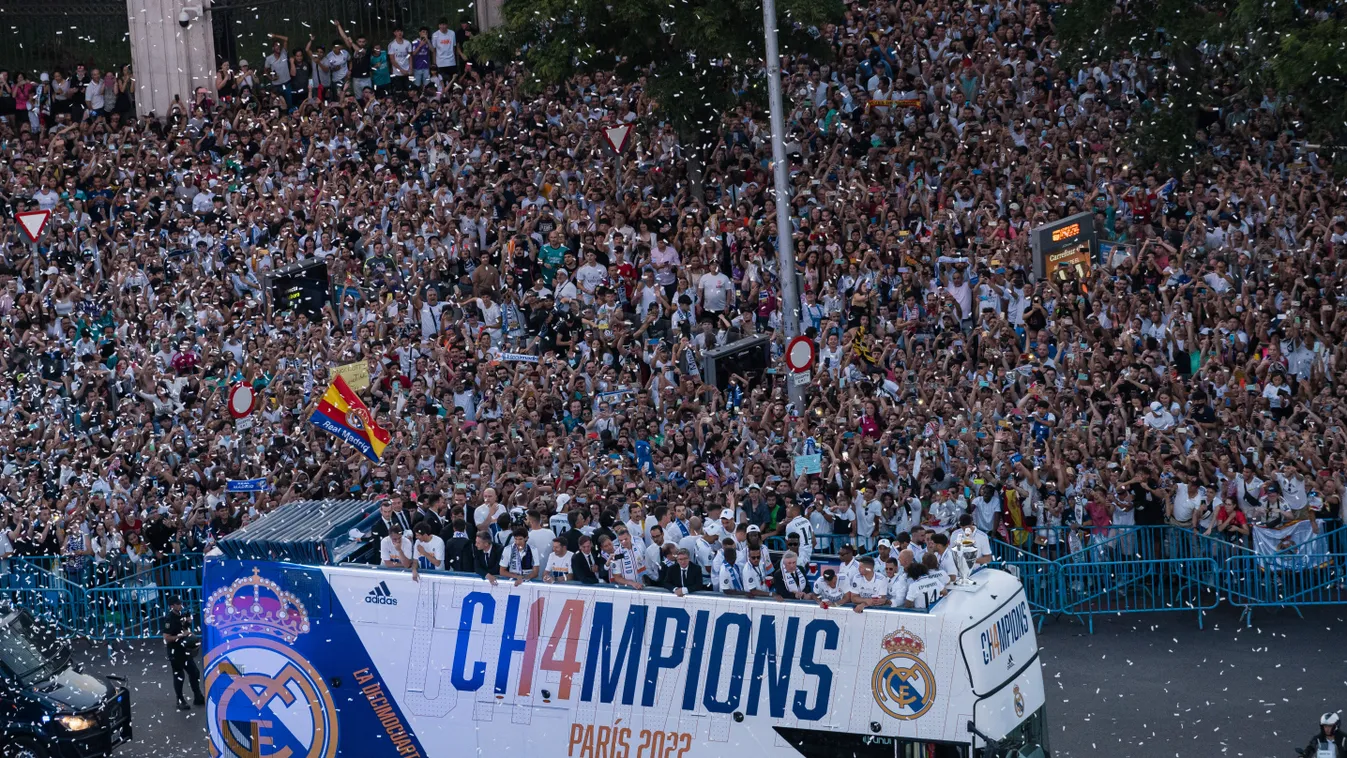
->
xmin=78 ymin=609 xmax=1347 ymax=758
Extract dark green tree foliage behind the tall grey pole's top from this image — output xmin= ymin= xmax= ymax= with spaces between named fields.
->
xmin=469 ymin=0 xmax=842 ymax=144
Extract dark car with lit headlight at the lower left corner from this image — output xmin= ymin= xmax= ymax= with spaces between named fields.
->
xmin=0 ymin=606 xmax=131 ymax=758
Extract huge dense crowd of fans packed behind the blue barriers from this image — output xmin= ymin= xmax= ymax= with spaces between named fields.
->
xmin=0 ymin=0 xmax=1347 ymax=611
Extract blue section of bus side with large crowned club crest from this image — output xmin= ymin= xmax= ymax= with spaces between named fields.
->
xmin=202 ymin=560 xmax=426 ymax=758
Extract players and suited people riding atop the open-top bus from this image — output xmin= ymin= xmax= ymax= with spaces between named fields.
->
xmin=369 ymin=490 xmax=993 ymax=613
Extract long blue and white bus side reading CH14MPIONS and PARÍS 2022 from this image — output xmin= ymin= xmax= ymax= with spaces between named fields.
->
xmin=203 ymin=560 xmax=1037 ymax=758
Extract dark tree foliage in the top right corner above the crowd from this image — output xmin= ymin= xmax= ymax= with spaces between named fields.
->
xmin=1056 ymin=0 xmax=1347 ymax=167
